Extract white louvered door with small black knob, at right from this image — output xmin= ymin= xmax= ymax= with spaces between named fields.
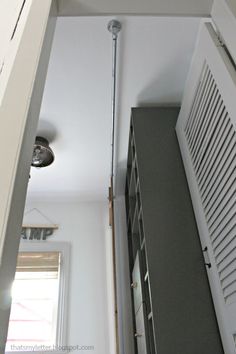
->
xmin=176 ymin=1 xmax=236 ymax=354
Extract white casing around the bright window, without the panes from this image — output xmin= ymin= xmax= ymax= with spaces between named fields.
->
xmin=6 ymin=241 xmax=70 ymax=354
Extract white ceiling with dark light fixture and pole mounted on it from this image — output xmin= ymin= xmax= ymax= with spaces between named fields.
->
xmin=28 ymin=16 xmax=199 ymax=200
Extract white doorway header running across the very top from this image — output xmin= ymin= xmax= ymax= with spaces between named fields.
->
xmin=59 ymin=0 xmax=213 ymax=16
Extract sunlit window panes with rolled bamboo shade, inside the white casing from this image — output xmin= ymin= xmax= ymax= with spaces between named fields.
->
xmin=6 ymin=252 xmax=60 ymax=352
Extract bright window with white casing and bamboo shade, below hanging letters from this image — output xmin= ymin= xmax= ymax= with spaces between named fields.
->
xmin=6 ymin=242 xmax=68 ymax=352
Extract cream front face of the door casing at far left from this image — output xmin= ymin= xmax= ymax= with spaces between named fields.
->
xmin=0 ymin=0 xmax=52 ymax=263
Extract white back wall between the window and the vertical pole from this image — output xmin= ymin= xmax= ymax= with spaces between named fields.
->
xmin=24 ymin=202 xmax=114 ymax=354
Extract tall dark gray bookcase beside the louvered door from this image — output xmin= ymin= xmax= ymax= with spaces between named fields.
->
xmin=126 ymin=107 xmax=223 ymax=354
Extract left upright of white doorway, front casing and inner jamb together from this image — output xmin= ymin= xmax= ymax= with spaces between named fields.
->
xmin=0 ymin=0 xmax=57 ymax=354
